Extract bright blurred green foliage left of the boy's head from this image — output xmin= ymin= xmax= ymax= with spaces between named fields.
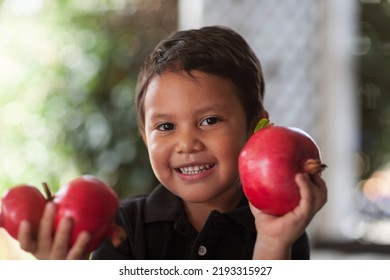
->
xmin=0 ymin=0 xmax=177 ymax=197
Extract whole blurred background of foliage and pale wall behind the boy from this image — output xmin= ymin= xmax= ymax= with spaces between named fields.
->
xmin=0 ymin=0 xmax=390 ymax=259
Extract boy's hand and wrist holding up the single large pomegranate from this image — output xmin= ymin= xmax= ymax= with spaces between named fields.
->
xmin=250 ymin=173 xmax=327 ymax=259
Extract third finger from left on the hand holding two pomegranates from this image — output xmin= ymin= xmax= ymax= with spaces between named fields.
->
xmin=50 ymin=217 xmax=73 ymax=259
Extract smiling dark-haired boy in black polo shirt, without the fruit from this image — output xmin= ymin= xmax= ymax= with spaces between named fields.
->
xmin=19 ymin=26 xmax=327 ymax=259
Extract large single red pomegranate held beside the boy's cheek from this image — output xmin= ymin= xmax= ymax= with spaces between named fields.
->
xmin=239 ymin=120 xmax=326 ymax=216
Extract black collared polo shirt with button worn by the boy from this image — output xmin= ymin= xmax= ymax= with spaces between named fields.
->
xmin=92 ymin=185 xmax=309 ymax=260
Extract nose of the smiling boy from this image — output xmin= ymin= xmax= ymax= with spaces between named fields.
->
xmin=175 ymin=129 xmax=204 ymax=153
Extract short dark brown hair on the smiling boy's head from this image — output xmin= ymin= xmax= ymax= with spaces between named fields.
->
xmin=136 ymin=26 xmax=264 ymax=131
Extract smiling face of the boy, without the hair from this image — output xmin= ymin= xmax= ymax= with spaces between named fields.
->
xmin=142 ymin=72 xmax=251 ymax=207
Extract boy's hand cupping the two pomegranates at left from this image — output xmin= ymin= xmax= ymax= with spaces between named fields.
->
xmin=18 ymin=202 xmax=90 ymax=259
